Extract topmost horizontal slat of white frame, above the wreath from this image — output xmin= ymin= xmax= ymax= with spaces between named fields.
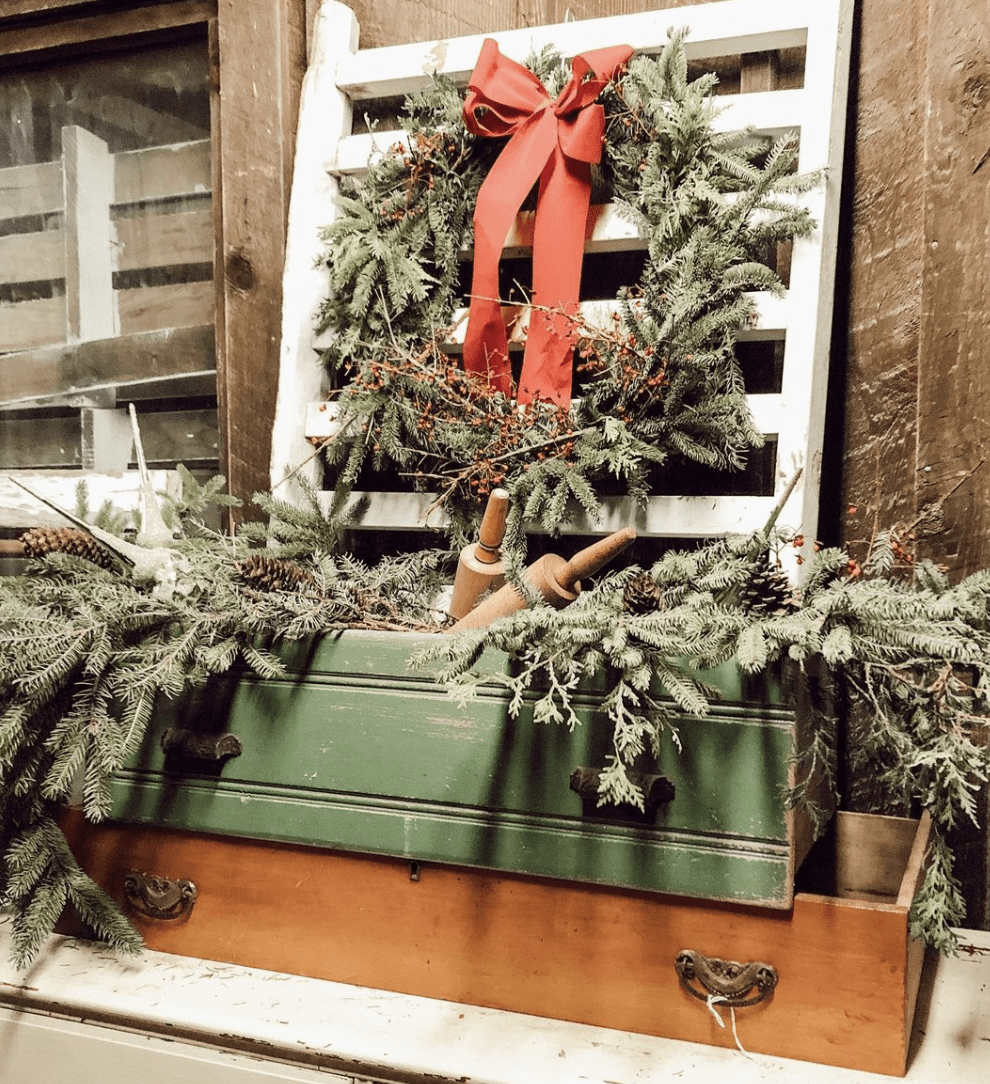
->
xmin=336 ymin=0 xmax=810 ymax=101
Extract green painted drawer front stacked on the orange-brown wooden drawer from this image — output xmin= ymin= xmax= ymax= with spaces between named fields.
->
xmin=114 ymin=631 xmax=795 ymax=906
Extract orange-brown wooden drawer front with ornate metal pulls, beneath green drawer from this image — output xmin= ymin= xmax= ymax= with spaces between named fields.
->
xmin=61 ymin=825 xmax=907 ymax=1074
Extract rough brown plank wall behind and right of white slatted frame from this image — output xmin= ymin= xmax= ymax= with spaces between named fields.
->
xmin=331 ymin=0 xmax=990 ymax=928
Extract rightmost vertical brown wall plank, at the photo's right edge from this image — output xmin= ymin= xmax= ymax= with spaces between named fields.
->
xmin=916 ymin=0 xmax=990 ymax=572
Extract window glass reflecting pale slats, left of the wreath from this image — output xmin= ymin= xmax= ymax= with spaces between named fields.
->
xmin=0 ymin=33 xmax=217 ymax=469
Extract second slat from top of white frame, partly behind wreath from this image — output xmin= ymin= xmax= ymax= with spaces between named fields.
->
xmin=329 ymin=90 xmax=805 ymax=177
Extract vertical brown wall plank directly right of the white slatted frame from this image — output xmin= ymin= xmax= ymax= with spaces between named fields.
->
xmin=835 ymin=0 xmax=928 ymax=545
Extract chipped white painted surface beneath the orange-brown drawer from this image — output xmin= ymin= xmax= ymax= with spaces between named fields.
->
xmin=0 ymin=930 xmax=990 ymax=1084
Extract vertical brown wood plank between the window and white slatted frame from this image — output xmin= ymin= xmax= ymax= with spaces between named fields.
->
xmin=214 ymin=0 xmax=306 ymax=511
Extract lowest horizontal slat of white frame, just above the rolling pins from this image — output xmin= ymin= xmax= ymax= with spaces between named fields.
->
xmin=321 ymin=492 xmax=774 ymax=539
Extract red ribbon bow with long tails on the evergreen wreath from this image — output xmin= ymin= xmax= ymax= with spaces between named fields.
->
xmin=464 ymin=38 xmax=632 ymax=405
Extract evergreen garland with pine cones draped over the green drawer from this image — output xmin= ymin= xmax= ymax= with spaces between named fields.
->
xmin=0 ymin=478 xmax=990 ymax=963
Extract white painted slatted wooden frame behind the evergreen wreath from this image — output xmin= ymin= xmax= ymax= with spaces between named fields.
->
xmin=272 ymin=0 xmax=853 ymax=544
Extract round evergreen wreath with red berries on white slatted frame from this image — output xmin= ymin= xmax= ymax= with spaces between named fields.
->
xmin=319 ymin=30 xmax=820 ymax=541
